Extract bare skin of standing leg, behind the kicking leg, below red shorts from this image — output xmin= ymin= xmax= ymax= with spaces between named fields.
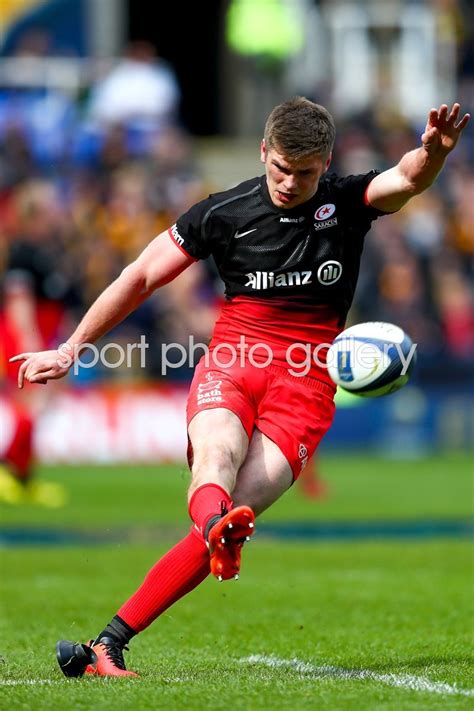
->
xmin=232 ymin=429 xmax=293 ymax=516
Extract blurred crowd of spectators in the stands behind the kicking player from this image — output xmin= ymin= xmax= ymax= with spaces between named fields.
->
xmin=0 ymin=37 xmax=474 ymax=390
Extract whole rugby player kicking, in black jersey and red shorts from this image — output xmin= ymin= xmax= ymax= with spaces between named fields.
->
xmin=9 ymin=97 xmax=469 ymax=676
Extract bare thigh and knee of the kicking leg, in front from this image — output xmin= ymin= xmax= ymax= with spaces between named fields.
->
xmin=188 ymin=407 xmax=249 ymax=495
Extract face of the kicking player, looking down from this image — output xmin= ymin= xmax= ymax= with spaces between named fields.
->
xmin=260 ymin=141 xmax=331 ymax=210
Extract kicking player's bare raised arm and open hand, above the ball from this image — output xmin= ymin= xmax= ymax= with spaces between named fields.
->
xmin=367 ymin=104 xmax=470 ymax=212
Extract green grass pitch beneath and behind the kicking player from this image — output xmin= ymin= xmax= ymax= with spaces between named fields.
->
xmin=0 ymin=454 xmax=474 ymax=711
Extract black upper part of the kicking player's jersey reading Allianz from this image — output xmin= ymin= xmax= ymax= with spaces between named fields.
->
xmin=170 ymin=171 xmax=385 ymax=316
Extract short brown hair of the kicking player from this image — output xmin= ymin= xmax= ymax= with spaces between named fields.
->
xmin=264 ymin=96 xmax=336 ymax=160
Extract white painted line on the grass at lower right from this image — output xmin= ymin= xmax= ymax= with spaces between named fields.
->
xmin=241 ymin=654 xmax=474 ymax=696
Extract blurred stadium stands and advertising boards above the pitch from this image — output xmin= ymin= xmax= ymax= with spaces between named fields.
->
xmin=0 ymin=0 xmax=474 ymax=461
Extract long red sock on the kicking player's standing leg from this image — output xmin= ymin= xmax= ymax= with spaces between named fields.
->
xmin=117 ymin=526 xmax=210 ymax=632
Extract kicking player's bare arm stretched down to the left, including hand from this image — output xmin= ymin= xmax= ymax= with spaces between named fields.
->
xmin=10 ymin=232 xmax=194 ymax=388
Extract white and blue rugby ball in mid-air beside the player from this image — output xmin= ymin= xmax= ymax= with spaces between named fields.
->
xmin=327 ymin=321 xmax=416 ymax=397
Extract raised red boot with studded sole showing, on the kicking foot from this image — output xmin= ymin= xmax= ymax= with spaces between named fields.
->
xmin=208 ymin=506 xmax=255 ymax=581
